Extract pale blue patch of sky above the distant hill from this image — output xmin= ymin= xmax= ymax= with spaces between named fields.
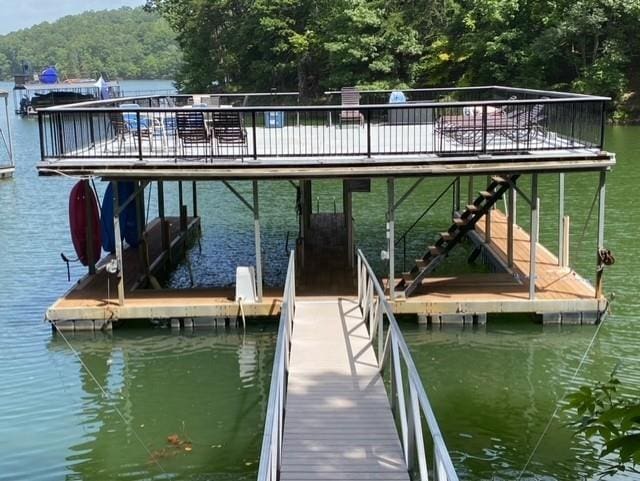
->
xmin=0 ymin=0 xmax=144 ymax=35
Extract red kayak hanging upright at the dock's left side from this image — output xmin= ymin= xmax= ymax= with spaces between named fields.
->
xmin=69 ymin=180 xmax=102 ymax=266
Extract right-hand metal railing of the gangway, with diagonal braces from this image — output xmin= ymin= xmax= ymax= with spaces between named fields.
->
xmin=358 ymin=249 xmax=458 ymax=481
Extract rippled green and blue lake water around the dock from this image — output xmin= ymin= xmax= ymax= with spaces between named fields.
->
xmin=0 ymin=82 xmax=640 ymax=480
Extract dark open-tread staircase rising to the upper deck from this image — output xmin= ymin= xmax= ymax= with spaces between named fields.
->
xmin=395 ymin=174 xmax=520 ymax=297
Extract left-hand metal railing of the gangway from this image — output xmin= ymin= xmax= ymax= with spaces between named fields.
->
xmin=258 ymin=251 xmax=296 ymax=481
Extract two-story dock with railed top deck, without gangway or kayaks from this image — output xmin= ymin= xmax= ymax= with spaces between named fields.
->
xmin=38 ymin=86 xmax=615 ymax=328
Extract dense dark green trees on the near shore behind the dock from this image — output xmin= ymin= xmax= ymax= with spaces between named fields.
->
xmin=145 ymin=0 xmax=640 ymax=119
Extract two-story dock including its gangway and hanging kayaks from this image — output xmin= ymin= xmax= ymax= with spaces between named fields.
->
xmin=38 ymin=86 xmax=615 ymax=481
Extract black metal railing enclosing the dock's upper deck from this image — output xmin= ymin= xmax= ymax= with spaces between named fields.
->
xmin=38 ymin=87 xmax=608 ymax=162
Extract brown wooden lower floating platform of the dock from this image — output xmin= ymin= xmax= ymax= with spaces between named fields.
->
xmin=46 ymin=206 xmax=608 ymax=330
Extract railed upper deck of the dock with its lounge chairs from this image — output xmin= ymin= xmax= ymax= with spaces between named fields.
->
xmin=38 ymin=86 xmax=615 ymax=179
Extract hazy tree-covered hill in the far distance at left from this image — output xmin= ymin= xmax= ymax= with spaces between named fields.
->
xmin=0 ymin=7 xmax=181 ymax=80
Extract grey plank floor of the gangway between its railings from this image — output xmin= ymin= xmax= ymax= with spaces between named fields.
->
xmin=280 ymin=299 xmax=409 ymax=481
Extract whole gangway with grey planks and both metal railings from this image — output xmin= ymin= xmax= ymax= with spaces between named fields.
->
xmin=258 ymin=251 xmax=458 ymax=481
